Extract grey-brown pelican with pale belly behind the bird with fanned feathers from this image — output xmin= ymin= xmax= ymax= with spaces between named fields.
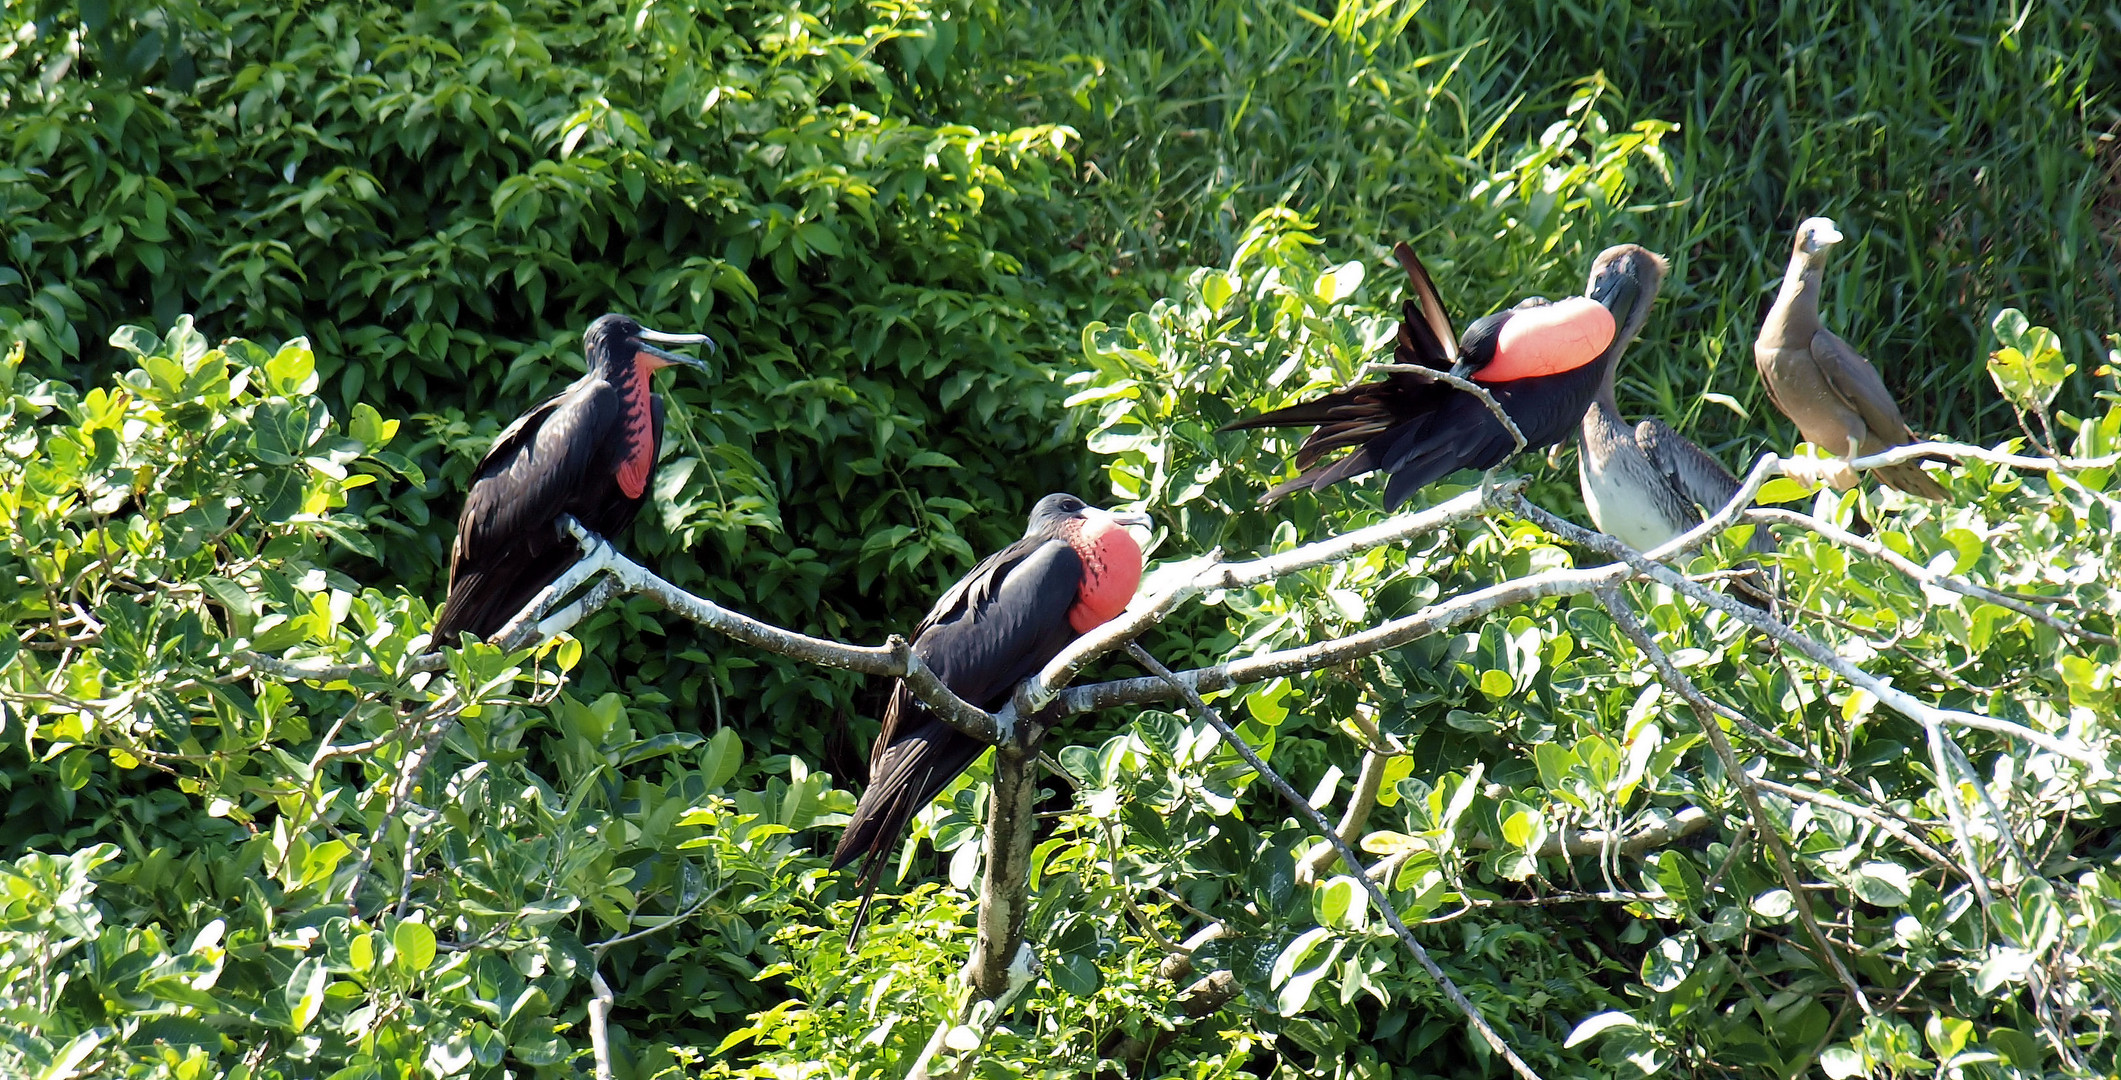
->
xmin=1576 ymin=244 xmax=1775 ymax=609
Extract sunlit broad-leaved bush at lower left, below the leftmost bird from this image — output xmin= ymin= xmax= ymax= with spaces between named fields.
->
xmin=0 ymin=318 xmax=853 ymax=1078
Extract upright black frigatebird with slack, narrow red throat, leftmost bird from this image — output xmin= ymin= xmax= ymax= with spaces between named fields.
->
xmin=435 ymin=314 xmax=713 ymax=645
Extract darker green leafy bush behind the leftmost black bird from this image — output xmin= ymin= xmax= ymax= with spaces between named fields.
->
xmin=0 ymin=0 xmax=1101 ymax=768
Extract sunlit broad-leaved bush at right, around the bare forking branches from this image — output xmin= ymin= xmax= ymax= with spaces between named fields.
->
xmin=1056 ymin=214 xmax=2121 ymax=1076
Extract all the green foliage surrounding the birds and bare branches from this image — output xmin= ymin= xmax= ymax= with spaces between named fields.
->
xmin=0 ymin=0 xmax=2121 ymax=1080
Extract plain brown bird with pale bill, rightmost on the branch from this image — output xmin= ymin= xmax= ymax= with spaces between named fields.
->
xmin=1752 ymin=219 xmax=1951 ymax=499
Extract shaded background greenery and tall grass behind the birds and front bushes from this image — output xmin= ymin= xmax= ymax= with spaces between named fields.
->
xmin=0 ymin=0 xmax=2121 ymax=1073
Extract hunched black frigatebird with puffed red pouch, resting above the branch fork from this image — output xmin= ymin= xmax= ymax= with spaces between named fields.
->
xmin=831 ymin=494 xmax=1150 ymax=929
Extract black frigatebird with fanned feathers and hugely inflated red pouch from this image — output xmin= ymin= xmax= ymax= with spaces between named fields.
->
xmin=1222 ymin=244 xmax=1631 ymax=509
